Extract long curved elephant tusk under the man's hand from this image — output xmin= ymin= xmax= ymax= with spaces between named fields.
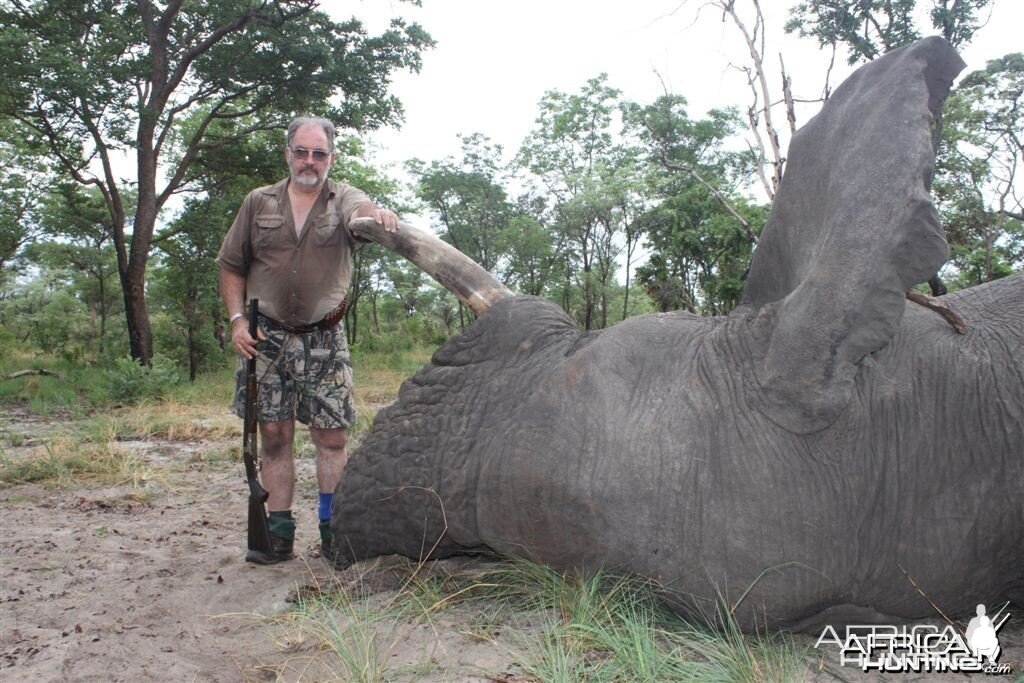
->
xmin=350 ymin=218 xmax=515 ymax=316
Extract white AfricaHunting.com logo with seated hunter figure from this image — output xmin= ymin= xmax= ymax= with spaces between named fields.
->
xmin=814 ymin=603 xmax=1013 ymax=674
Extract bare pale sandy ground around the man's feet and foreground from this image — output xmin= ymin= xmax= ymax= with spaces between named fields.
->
xmin=0 ymin=415 xmax=1024 ymax=683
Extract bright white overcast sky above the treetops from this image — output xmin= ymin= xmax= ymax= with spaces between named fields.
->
xmin=350 ymin=0 xmax=1024 ymax=184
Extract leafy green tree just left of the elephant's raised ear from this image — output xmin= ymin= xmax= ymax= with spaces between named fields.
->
xmin=626 ymin=95 xmax=767 ymax=314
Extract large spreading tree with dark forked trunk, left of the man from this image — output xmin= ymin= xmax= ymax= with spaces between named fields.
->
xmin=0 ymin=0 xmax=431 ymax=362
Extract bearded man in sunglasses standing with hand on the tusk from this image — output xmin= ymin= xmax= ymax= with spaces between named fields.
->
xmin=217 ymin=117 xmax=398 ymax=564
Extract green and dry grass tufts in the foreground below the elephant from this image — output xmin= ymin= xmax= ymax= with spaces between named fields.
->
xmin=268 ymin=560 xmax=807 ymax=683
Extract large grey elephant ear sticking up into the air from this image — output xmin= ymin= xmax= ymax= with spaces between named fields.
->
xmin=740 ymin=37 xmax=965 ymax=433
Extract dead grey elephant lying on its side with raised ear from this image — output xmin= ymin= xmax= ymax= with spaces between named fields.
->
xmin=332 ymin=38 xmax=1024 ymax=630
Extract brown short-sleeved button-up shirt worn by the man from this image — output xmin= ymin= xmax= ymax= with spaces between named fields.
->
xmin=217 ymin=178 xmax=372 ymax=326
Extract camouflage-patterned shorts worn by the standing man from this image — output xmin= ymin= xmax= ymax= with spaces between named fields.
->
xmin=234 ymin=315 xmax=355 ymax=429
